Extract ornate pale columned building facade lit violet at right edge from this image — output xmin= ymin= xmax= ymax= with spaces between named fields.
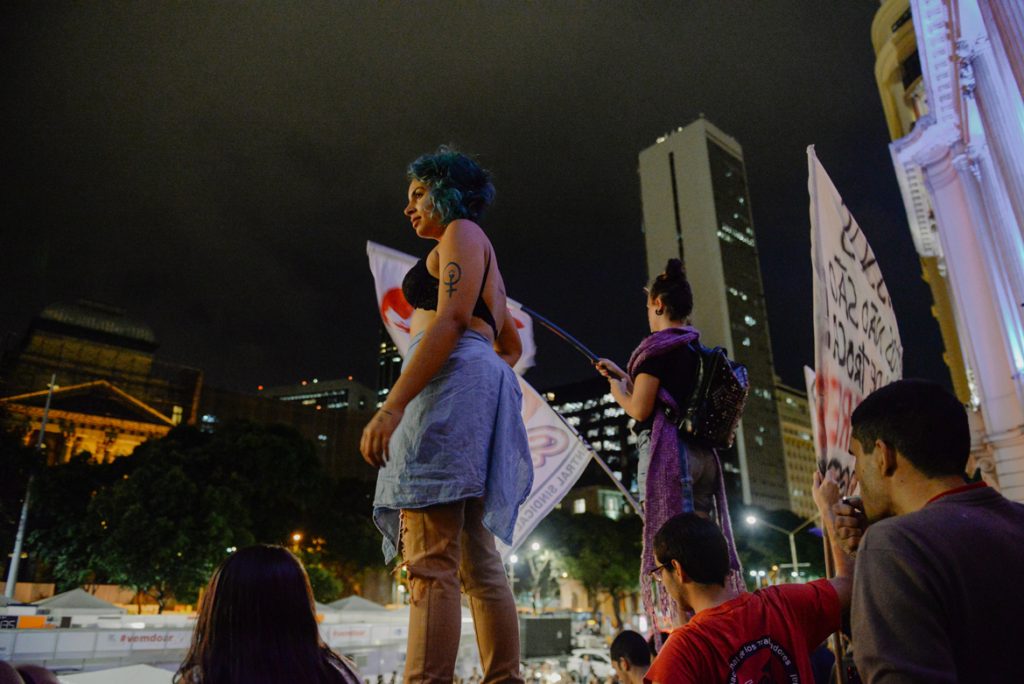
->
xmin=872 ymin=0 xmax=1024 ymax=501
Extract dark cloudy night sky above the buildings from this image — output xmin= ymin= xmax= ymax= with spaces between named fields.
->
xmin=0 ymin=0 xmax=949 ymax=390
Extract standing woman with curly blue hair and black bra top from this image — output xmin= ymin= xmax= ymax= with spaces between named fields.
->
xmin=359 ymin=147 xmax=534 ymax=682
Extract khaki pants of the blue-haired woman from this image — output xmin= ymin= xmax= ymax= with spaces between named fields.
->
xmin=401 ymin=499 xmax=523 ymax=684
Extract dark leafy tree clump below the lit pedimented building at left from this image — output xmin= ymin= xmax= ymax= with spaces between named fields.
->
xmin=32 ymin=422 xmax=383 ymax=610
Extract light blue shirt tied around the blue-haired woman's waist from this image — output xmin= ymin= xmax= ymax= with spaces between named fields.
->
xmin=374 ymin=330 xmax=534 ymax=563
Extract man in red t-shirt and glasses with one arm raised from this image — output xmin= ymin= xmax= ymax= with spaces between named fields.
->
xmin=644 ymin=475 xmax=853 ymax=684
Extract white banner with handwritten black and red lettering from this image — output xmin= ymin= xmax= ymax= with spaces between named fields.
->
xmin=807 ymin=145 xmax=903 ymax=494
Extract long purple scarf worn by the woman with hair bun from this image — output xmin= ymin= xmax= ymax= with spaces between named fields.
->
xmin=627 ymin=327 xmax=746 ymax=634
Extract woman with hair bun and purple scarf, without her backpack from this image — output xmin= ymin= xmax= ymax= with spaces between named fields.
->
xmin=597 ymin=259 xmax=741 ymax=612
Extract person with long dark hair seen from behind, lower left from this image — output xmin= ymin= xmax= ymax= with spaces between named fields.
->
xmin=174 ymin=545 xmax=359 ymax=684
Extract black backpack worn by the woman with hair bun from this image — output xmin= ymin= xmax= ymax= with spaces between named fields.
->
xmin=666 ymin=343 xmax=751 ymax=448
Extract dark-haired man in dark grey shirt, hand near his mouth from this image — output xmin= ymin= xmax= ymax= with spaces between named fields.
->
xmin=833 ymin=380 xmax=1024 ymax=684
